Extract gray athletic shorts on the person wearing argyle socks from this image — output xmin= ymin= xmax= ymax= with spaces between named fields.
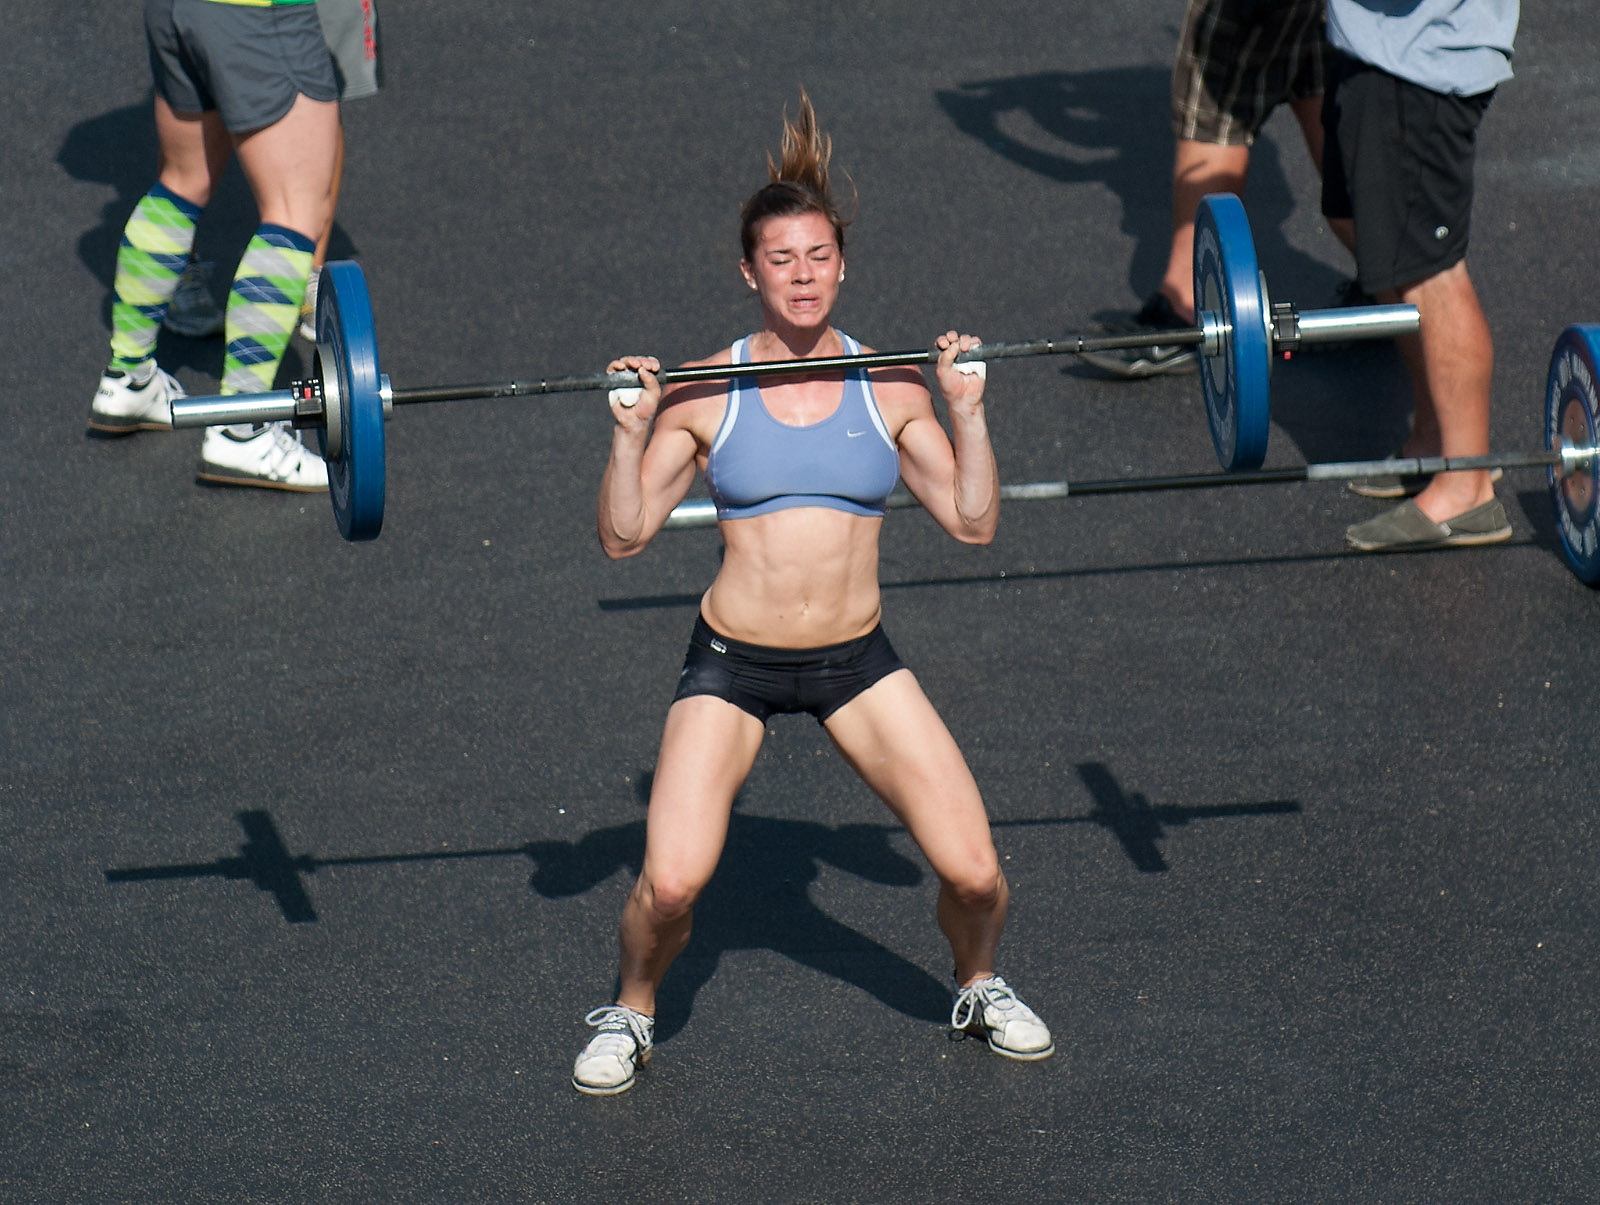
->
xmin=144 ymin=0 xmax=339 ymax=134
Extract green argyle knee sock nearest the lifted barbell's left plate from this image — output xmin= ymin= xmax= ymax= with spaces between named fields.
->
xmin=222 ymin=222 xmax=317 ymax=394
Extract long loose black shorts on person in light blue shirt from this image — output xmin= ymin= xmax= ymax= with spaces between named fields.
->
xmin=1322 ymin=51 xmax=1494 ymax=293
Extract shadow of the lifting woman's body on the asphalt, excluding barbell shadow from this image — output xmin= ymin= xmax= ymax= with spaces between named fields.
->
xmin=525 ymin=775 xmax=950 ymax=1039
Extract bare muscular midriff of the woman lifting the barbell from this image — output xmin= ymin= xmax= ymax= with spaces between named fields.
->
xmin=701 ymin=506 xmax=883 ymax=648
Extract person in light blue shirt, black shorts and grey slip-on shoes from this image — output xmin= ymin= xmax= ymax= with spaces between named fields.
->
xmin=1322 ymin=0 xmax=1518 ymax=552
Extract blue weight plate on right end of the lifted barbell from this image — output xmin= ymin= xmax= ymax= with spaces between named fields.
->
xmin=1195 ymin=192 xmax=1272 ymax=472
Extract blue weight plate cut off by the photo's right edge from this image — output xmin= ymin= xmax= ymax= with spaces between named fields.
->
xmin=1544 ymin=325 xmax=1600 ymax=586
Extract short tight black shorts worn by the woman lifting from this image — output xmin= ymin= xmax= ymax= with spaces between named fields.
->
xmin=672 ymin=616 xmax=906 ymax=723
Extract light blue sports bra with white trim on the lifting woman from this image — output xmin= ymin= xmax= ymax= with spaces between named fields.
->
xmin=706 ymin=331 xmax=899 ymax=518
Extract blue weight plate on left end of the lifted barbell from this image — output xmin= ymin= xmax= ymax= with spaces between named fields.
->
xmin=317 ymin=267 xmax=384 ymax=541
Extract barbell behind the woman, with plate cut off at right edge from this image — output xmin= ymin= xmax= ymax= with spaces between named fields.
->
xmin=666 ymin=325 xmax=1600 ymax=586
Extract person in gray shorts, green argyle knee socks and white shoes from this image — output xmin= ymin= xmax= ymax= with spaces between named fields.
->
xmin=90 ymin=0 xmax=339 ymax=490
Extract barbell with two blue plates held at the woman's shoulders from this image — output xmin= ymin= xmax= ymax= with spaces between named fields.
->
xmin=173 ymin=194 xmax=1418 ymax=539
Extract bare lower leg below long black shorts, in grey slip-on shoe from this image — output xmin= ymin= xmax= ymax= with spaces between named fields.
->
xmin=1381 ymin=261 xmax=1494 ymax=523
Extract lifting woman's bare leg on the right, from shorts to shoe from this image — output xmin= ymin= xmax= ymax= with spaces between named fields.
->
xmin=827 ymin=669 xmax=1011 ymax=987
